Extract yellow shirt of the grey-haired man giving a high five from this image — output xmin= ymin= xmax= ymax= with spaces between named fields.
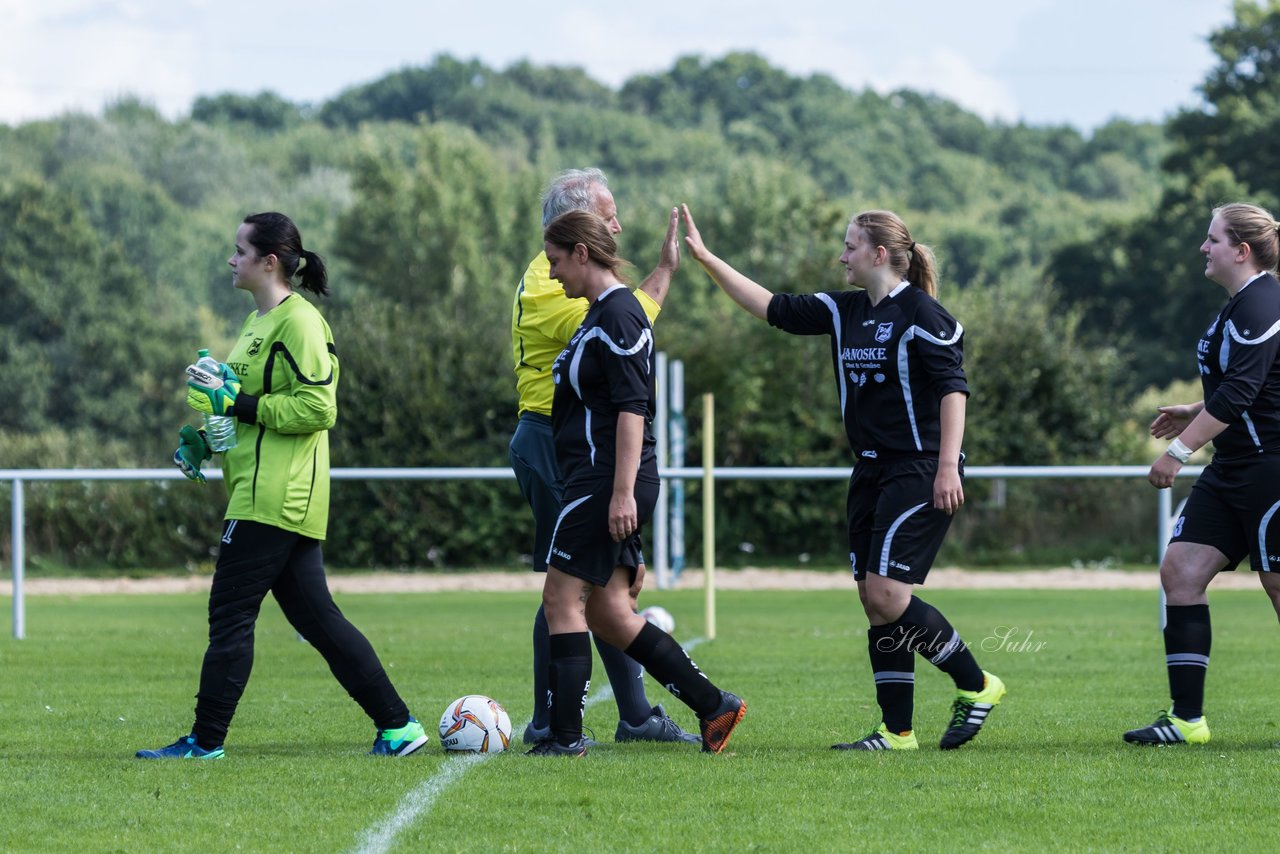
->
xmin=511 ymin=252 xmax=662 ymax=416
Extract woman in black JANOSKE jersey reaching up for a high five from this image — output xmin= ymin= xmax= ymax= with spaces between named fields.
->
xmin=684 ymin=206 xmax=1005 ymax=750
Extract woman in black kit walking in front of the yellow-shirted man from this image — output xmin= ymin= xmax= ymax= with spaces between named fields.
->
xmin=529 ymin=210 xmax=746 ymax=755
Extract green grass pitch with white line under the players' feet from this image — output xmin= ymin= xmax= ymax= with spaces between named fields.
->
xmin=0 ymin=590 xmax=1280 ymax=851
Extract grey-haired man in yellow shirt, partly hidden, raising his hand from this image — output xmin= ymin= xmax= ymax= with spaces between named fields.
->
xmin=507 ymin=169 xmax=699 ymax=744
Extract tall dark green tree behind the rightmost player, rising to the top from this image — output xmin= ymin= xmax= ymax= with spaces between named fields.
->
xmin=1050 ymin=0 xmax=1280 ymax=388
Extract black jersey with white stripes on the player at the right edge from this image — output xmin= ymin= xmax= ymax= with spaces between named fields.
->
xmin=1196 ymin=273 xmax=1280 ymax=460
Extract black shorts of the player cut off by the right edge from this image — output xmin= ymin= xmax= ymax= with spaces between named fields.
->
xmin=1169 ymin=455 xmax=1280 ymax=572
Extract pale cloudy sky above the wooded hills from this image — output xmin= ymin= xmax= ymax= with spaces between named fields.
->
xmin=0 ymin=0 xmax=1231 ymax=131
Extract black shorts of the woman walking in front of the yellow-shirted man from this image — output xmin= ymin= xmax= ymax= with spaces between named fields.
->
xmin=547 ymin=478 xmax=658 ymax=586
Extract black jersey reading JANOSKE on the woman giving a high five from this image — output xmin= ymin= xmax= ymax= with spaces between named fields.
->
xmin=768 ymin=282 xmax=969 ymax=460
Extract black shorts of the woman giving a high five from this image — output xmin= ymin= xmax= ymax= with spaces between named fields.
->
xmin=846 ymin=460 xmax=964 ymax=584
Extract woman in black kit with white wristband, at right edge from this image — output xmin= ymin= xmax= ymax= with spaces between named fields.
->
xmin=1124 ymin=204 xmax=1280 ymax=744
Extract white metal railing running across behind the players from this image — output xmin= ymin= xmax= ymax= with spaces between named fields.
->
xmin=0 ymin=466 xmax=1203 ymax=639
